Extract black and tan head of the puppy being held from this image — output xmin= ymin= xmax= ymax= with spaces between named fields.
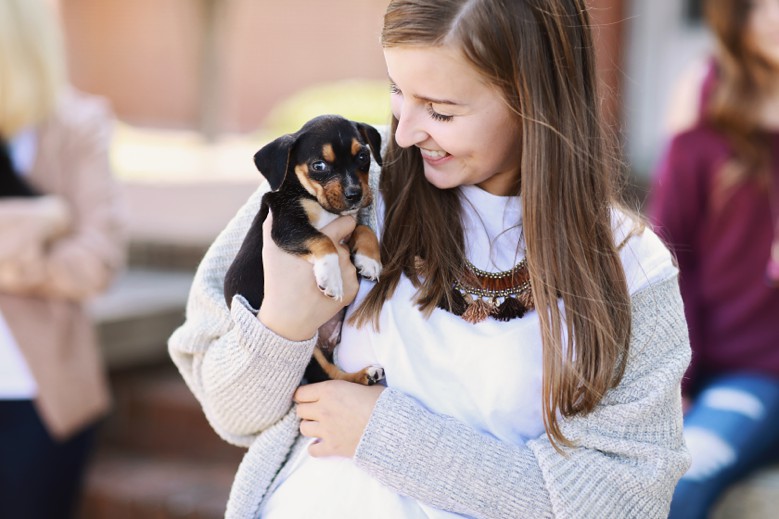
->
xmin=254 ymin=115 xmax=381 ymax=214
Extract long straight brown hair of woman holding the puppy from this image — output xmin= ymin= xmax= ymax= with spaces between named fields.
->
xmin=355 ymin=0 xmax=630 ymax=446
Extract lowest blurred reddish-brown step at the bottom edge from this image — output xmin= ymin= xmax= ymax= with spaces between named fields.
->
xmin=78 ymin=451 xmax=237 ymax=519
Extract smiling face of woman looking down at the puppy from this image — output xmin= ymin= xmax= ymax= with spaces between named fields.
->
xmin=384 ymin=46 xmax=522 ymax=195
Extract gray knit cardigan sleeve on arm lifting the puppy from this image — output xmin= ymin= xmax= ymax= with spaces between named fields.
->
xmin=168 ymin=184 xmax=317 ymax=447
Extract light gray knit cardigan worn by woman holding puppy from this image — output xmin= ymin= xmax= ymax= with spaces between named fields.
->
xmin=169 ymin=175 xmax=690 ymax=519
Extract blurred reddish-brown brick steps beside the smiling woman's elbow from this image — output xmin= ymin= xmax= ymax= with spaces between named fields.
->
xmin=78 ymin=362 xmax=244 ymax=519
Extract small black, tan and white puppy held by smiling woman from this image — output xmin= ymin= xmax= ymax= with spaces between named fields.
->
xmin=224 ymin=115 xmax=384 ymax=385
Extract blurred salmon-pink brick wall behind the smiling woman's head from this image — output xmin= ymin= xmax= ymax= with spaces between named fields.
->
xmin=58 ymin=0 xmax=624 ymax=135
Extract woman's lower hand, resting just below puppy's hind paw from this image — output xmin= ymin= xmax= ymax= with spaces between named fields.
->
xmin=293 ymin=380 xmax=385 ymax=458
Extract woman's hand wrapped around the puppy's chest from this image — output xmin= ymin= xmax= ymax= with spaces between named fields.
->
xmin=257 ymin=214 xmax=358 ymax=341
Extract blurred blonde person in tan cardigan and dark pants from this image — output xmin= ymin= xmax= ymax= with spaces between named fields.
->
xmin=0 ymin=0 xmax=125 ymax=519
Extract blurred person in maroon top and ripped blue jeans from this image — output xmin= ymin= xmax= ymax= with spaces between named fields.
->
xmin=650 ymin=0 xmax=779 ymax=519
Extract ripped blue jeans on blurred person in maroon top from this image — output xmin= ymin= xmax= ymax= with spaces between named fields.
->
xmin=669 ymin=374 xmax=779 ymax=519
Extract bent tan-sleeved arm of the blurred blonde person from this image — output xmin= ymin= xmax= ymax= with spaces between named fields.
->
xmin=0 ymin=92 xmax=126 ymax=301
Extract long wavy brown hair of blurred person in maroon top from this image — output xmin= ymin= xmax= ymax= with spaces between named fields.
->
xmin=704 ymin=0 xmax=779 ymax=191
